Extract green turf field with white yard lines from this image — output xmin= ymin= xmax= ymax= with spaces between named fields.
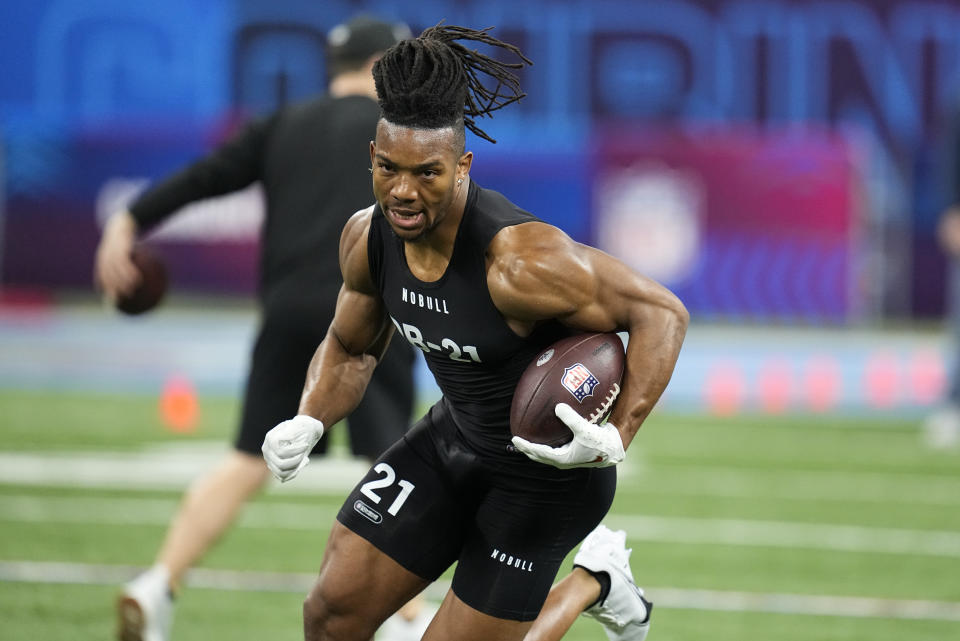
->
xmin=0 ymin=391 xmax=960 ymax=641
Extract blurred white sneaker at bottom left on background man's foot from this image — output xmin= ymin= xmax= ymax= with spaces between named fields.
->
xmin=117 ymin=565 xmax=173 ymax=641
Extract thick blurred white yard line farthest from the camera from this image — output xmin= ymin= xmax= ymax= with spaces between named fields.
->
xmin=0 ymin=441 xmax=960 ymax=508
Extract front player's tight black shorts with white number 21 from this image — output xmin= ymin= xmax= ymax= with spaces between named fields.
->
xmin=337 ymin=400 xmax=616 ymax=621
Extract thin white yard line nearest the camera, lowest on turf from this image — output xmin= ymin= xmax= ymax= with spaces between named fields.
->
xmin=0 ymin=561 xmax=960 ymax=621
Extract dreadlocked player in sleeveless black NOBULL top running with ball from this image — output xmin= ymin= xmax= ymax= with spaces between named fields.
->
xmin=263 ymin=25 xmax=688 ymax=641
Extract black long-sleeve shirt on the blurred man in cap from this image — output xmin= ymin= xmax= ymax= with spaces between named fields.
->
xmin=130 ymin=96 xmax=379 ymax=320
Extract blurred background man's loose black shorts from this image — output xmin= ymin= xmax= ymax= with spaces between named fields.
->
xmin=234 ymin=312 xmax=415 ymax=460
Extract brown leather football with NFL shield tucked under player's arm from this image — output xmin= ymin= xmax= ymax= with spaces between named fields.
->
xmin=510 ymin=333 xmax=625 ymax=447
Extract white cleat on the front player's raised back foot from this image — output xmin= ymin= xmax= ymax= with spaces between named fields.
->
xmin=573 ymin=524 xmax=653 ymax=641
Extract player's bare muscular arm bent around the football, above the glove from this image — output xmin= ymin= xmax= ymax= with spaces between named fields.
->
xmin=487 ymin=223 xmax=689 ymax=448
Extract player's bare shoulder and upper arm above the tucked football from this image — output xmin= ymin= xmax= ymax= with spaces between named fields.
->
xmin=488 ymin=223 xmax=679 ymax=332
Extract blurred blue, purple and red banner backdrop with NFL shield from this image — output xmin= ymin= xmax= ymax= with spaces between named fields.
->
xmin=0 ymin=0 xmax=960 ymax=324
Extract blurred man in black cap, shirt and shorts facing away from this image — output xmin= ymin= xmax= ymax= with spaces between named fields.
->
xmin=95 ymin=17 xmax=424 ymax=641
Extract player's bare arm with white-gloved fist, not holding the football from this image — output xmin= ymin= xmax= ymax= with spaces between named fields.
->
xmin=261 ymin=207 xmax=393 ymax=481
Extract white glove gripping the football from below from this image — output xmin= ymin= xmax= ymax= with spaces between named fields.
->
xmin=512 ymin=403 xmax=625 ymax=469
